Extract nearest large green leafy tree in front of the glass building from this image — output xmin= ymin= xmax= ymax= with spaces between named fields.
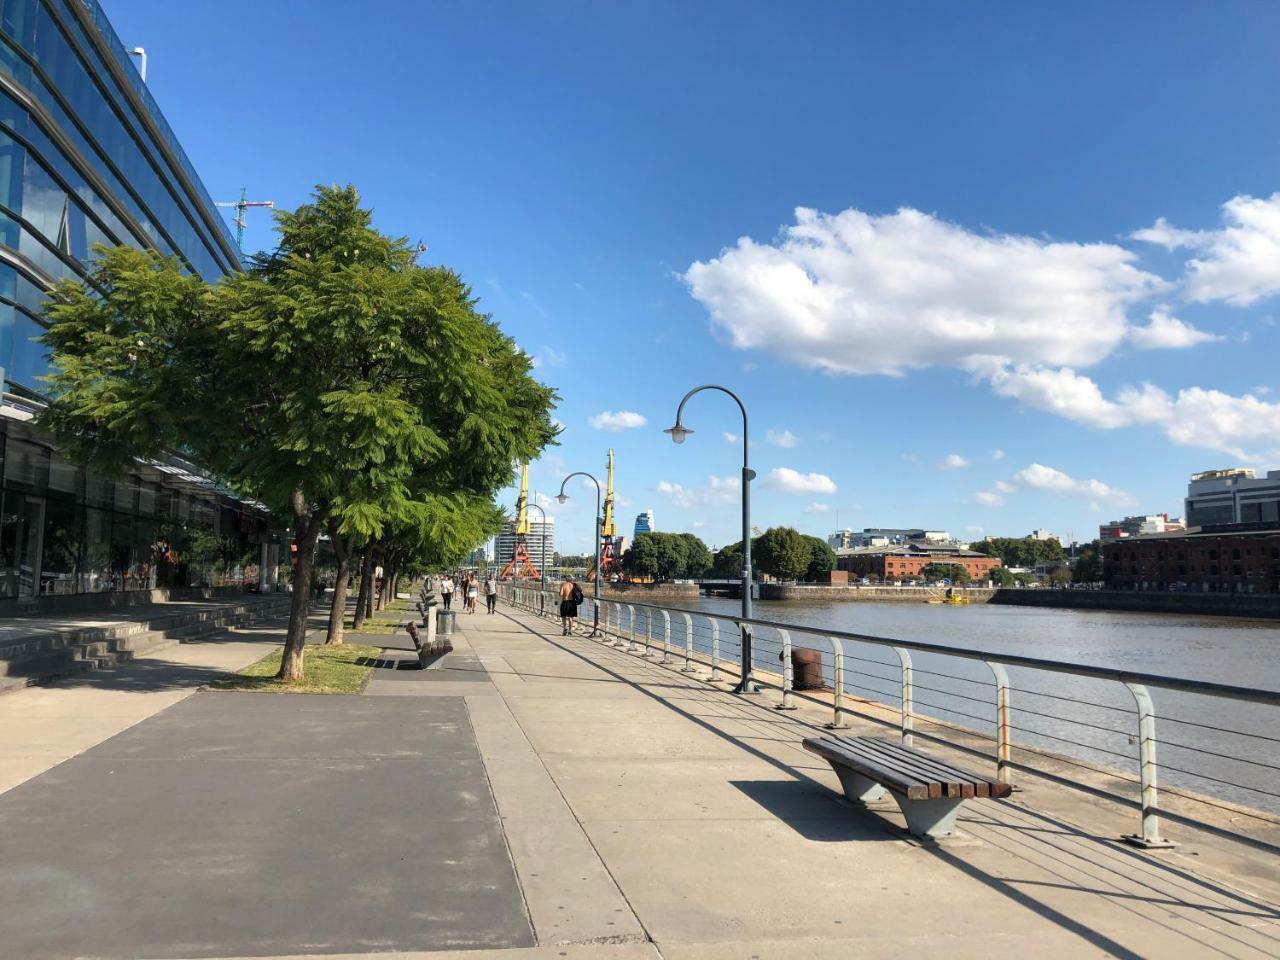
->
xmin=41 ymin=187 xmax=556 ymax=680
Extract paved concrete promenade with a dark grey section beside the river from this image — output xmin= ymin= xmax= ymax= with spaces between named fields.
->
xmin=0 ymin=604 xmax=1280 ymax=960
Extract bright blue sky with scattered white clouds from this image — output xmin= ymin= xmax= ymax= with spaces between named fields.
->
xmin=104 ymin=0 xmax=1280 ymax=550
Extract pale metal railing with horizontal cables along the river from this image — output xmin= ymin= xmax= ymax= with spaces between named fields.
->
xmin=502 ymin=584 xmax=1280 ymax=847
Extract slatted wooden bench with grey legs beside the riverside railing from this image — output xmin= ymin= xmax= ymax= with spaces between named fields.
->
xmin=804 ymin=736 xmax=1012 ymax=840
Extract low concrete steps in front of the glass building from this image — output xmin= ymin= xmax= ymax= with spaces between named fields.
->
xmin=0 ymin=594 xmax=289 ymax=694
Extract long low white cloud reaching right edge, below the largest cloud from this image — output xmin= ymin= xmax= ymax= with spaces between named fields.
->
xmin=979 ymin=361 xmax=1280 ymax=462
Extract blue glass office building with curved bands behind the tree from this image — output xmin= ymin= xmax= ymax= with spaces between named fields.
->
xmin=0 ymin=0 xmax=279 ymax=611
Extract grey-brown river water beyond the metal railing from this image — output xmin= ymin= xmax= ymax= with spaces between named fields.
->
xmin=632 ymin=598 xmax=1280 ymax=813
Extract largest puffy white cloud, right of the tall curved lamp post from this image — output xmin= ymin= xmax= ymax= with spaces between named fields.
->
xmin=684 ymin=207 xmax=1167 ymax=374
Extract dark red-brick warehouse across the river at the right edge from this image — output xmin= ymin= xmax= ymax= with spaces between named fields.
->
xmin=1102 ymin=524 xmax=1280 ymax=594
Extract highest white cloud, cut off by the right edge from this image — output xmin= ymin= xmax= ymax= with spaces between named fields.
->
xmin=1133 ymin=193 xmax=1280 ymax=306
